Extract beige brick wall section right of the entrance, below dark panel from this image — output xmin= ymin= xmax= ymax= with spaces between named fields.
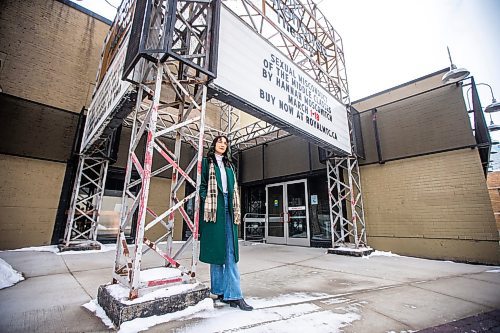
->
xmin=361 ymin=149 xmax=500 ymax=262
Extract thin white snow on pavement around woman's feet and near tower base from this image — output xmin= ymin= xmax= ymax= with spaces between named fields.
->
xmin=83 ymin=293 xmax=361 ymax=333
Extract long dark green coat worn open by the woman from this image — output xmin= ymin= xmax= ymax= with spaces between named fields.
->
xmin=199 ymin=158 xmax=239 ymax=265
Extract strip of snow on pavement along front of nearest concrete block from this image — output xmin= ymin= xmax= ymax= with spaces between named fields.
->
xmin=118 ymin=298 xmax=214 ymax=333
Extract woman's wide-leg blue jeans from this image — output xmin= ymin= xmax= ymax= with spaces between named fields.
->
xmin=210 ymin=193 xmax=243 ymax=300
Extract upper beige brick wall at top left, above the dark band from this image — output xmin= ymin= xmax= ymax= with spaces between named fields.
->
xmin=0 ymin=0 xmax=109 ymax=112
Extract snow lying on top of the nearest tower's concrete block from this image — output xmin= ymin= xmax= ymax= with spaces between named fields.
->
xmin=106 ymin=283 xmax=199 ymax=304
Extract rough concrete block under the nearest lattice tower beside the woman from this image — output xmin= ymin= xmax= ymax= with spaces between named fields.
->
xmin=97 ymin=283 xmax=210 ymax=328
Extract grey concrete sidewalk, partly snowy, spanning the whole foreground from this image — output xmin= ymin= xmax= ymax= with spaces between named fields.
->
xmin=0 ymin=242 xmax=500 ymax=333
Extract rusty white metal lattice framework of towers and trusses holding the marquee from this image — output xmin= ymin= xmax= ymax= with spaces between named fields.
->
xmin=65 ymin=0 xmax=366 ymax=298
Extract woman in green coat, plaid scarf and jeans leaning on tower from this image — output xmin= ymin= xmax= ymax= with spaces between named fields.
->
xmin=200 ymin=135 xmax=253 ymax=311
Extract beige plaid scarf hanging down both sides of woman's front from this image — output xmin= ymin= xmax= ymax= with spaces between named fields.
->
xmin=203 ymin=161 xmax=241 ymax=224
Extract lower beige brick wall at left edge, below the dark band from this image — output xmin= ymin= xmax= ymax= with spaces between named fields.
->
xmin=0 ymin=154 xmax=66 ymax=249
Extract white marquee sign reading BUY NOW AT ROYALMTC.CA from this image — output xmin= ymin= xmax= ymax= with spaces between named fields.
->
xmin=211 ymin=6 xmax=351 ymax=154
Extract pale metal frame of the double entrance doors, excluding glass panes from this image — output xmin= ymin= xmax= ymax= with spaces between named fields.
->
xmin=265 ymin=178 xmax=311 ymax=247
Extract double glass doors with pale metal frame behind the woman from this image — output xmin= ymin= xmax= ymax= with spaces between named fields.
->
xmin=266 ymin=179 xmax=310 ymax=246
